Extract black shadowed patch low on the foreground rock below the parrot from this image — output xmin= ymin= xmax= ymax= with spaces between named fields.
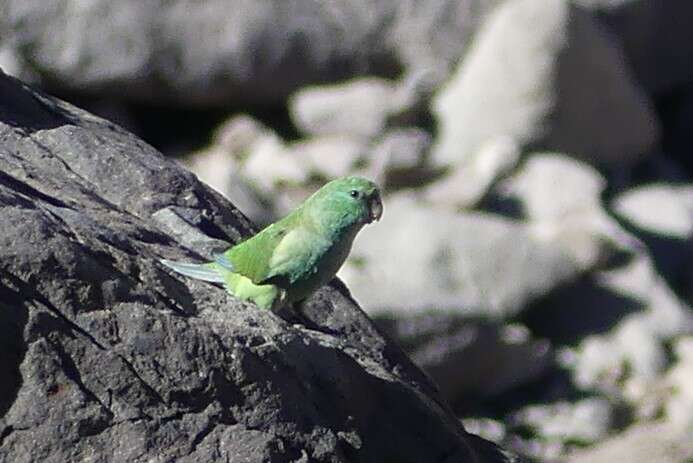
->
xmin=249 ymin=339 xmax=484 ymax=463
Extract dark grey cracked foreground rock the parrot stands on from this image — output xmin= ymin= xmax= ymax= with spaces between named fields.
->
xmin=0 ymin=70 xmax=509 ymax=463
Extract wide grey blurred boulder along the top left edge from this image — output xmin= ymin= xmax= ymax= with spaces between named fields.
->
xmin=0 ymin=0 xmax=498 ymax=107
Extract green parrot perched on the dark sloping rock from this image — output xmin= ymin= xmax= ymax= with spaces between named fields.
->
xmin=162 ymin=177 xmax=383 ymax=310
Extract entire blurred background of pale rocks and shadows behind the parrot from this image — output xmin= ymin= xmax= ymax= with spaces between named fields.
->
xmin=0 ymin=0 xmax=693 ymax=463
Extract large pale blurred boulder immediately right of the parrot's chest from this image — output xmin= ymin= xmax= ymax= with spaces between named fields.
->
xmin=340 ymin=192 xmax=580 ymax=317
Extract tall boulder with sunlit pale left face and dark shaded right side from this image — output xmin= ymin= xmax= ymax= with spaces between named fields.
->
xmin=433 ymin=0 xmax=658 ymax=166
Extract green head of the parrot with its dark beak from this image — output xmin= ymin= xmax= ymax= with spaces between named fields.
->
xmin=314 ymin=176 xmax=383 ymax=228
